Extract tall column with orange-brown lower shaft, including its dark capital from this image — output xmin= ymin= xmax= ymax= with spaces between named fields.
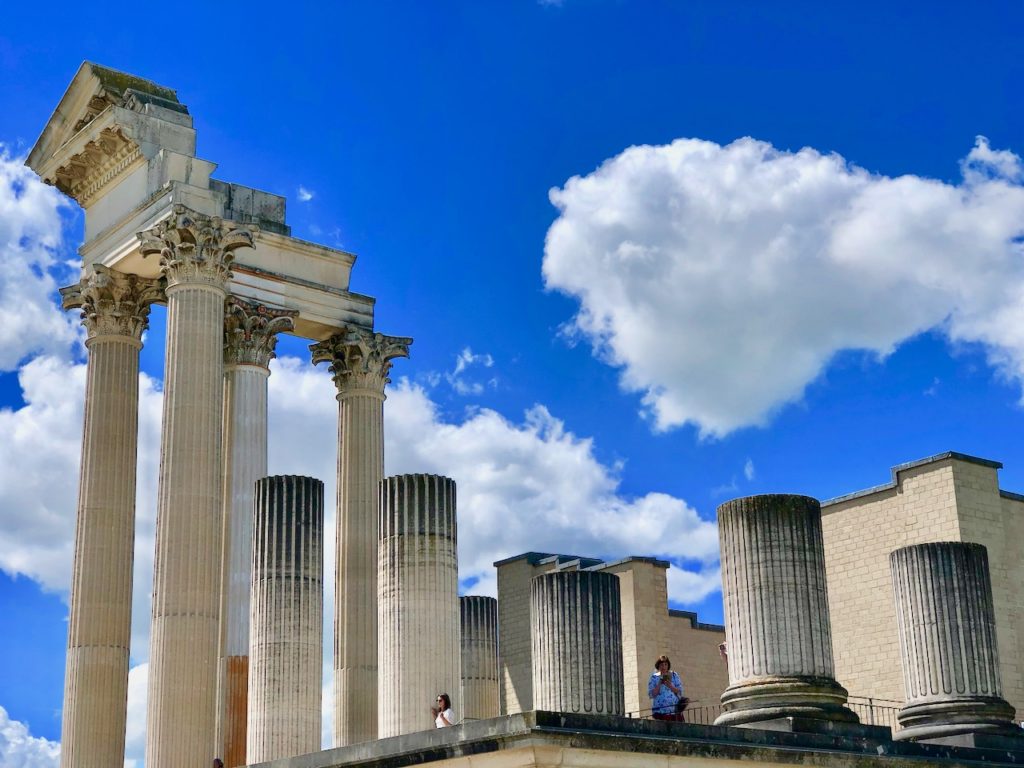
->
xmin=217 ymin=296 xmax=297 ymax=768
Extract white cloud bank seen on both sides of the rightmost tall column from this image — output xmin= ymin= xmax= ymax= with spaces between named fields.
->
xmin=269 ymin=357 xmax=718 ymax=604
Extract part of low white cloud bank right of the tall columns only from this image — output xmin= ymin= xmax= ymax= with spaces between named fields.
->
xmin=385 ymin=381 xmax=718 ymax=602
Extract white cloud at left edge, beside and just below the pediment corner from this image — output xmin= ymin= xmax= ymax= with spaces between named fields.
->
xmin=0 ymin=144 xmax=79 ymax=372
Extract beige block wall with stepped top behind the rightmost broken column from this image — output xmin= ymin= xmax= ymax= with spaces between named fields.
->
xmin=822 ymin=455 xmax=1024 ymax=710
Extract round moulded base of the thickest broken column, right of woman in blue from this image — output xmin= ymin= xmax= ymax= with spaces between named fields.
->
xmin=715 ymin=677 xmax=860 ymax=727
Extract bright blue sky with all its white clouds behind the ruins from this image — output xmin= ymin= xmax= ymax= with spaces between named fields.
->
xmin=0 ymin=0 xmax=1024 ymax=765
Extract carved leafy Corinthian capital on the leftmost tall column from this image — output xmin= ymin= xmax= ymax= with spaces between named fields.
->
xmin=60 ymin=264 xmax=164 ymax=341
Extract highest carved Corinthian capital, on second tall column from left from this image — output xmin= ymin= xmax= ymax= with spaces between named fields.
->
xmin=138 ymin=205 xmax=259 ymax=289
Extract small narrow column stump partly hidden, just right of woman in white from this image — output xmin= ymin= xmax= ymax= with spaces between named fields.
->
xmin=459 ymin=595 xmax=501 ymax=720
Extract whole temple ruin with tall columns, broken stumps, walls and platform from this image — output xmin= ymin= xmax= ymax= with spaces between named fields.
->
xmin=27 ymin=62 xmax=1024 ymax=768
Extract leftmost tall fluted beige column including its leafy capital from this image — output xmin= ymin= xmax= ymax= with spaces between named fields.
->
xmin=60 ymin=265 xmax=162 ymax=768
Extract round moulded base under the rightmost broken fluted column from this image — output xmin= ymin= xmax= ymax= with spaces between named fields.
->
xmin=893 ymin=696 xmax=1022 ymax=743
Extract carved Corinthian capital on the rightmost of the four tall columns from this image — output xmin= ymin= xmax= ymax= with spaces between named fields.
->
xmin=309 ymin=328 xmax=413 ymax=397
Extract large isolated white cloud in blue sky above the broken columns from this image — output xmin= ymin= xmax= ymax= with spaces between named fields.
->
xmin=544 ymin=138 xmax=1024 ymax=435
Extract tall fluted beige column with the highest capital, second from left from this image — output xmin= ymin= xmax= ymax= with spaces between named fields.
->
xmin=139 ymin=206 xmax=253 ymax=768
